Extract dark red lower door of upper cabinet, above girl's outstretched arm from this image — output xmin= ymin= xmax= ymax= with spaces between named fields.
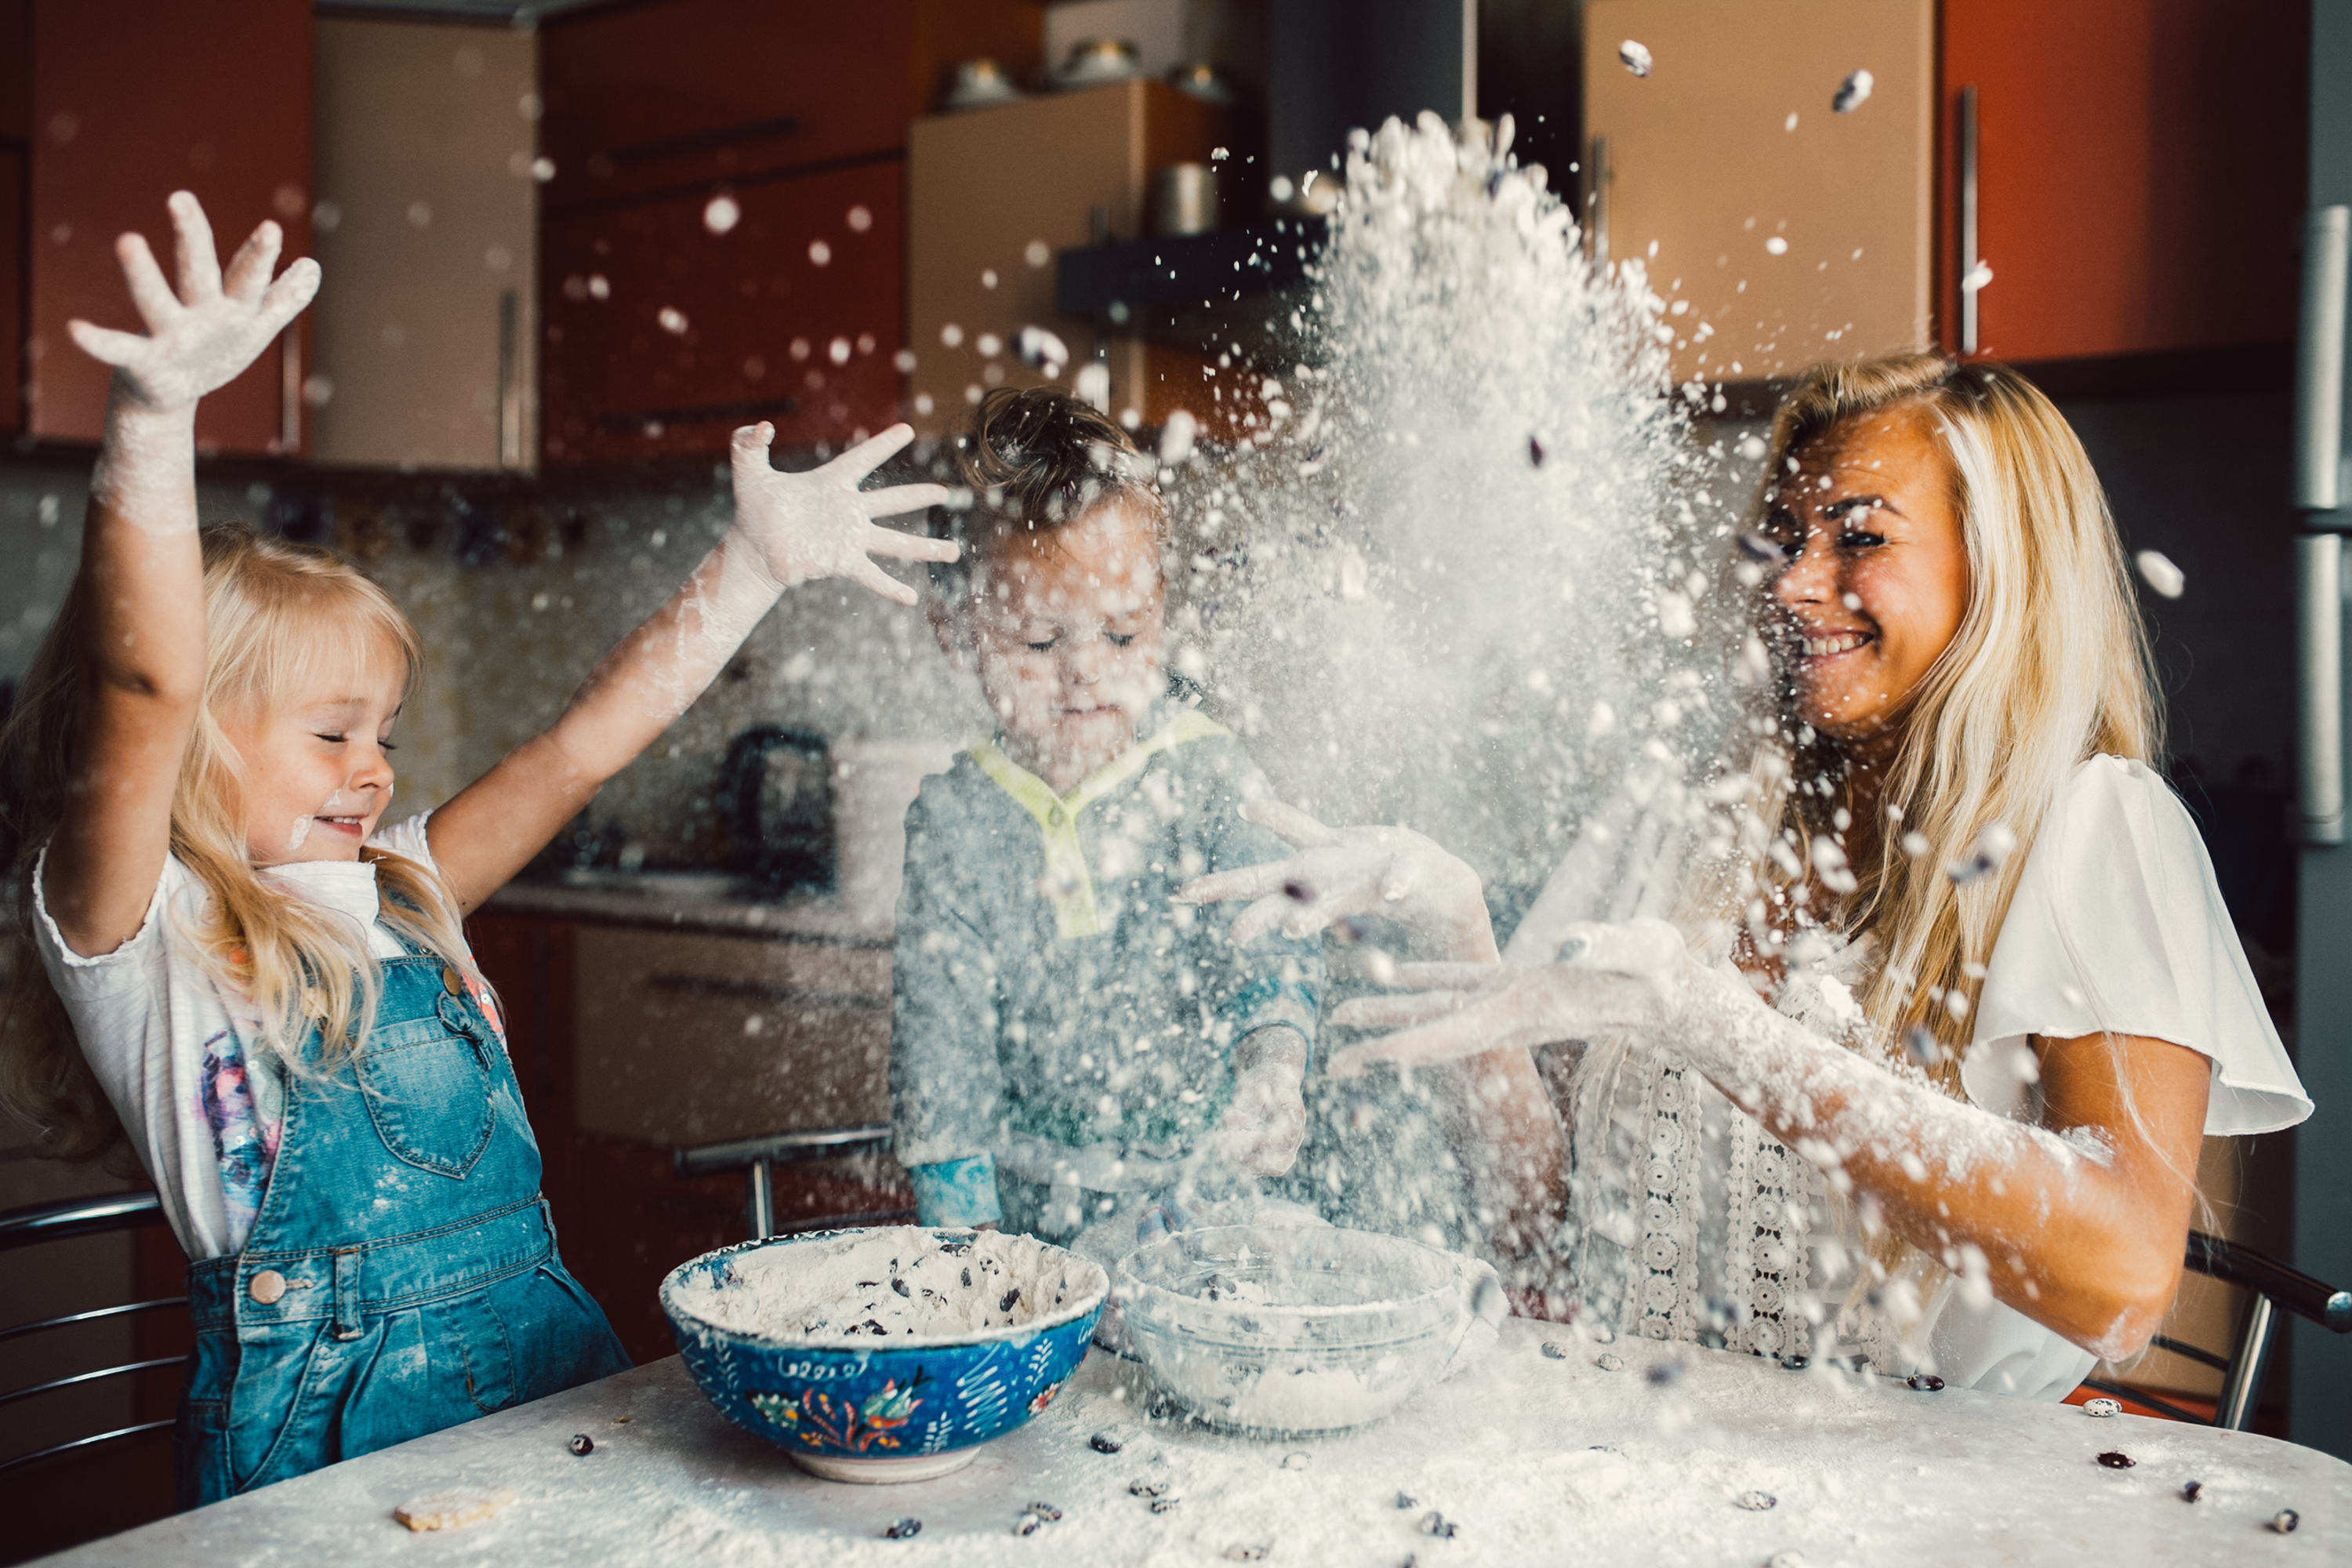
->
xmin=541 ymin=162 xmax=903 ymax=463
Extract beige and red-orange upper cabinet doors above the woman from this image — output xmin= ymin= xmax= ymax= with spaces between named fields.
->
xmin=1585 ymin=0 xmax=2307 ymax=381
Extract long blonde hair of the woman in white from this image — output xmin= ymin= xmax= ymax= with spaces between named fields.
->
xmin=1757 ymin=355 xmax=2161 ymax=1093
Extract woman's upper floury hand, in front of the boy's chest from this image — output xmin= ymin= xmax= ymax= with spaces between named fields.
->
xmin=1176 ymin=799 xmax=1501 ymax=964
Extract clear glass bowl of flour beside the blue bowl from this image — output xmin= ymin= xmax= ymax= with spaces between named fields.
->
xmin=1115 ymin=1225 xmax=1503 ymax=1432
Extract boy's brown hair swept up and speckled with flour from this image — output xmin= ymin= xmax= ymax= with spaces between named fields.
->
xmin=931 ymin=386 xmax=1167 ymax=595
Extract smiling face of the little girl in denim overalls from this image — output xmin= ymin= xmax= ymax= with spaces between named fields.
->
xmin=221 ymin=659 xmax=407 ymax=865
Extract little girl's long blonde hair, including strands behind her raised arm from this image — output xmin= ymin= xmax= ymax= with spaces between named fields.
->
xmin=0 ymin=524 xmax=480 ymax=1159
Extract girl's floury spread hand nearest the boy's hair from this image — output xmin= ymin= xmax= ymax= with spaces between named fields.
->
xmin=734 ymin=421 xmax=957 ymax=604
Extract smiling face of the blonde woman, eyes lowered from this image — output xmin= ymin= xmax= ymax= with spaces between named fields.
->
xmin=1764 ymin=402 xmax=1969 ymax=741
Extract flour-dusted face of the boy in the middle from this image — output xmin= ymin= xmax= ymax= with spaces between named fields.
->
xmin=967 ymin=503 xmax=1167 ymax=792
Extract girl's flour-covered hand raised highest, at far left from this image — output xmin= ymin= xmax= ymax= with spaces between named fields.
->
xmin=66 ymin=191 xmax=318 ymax=412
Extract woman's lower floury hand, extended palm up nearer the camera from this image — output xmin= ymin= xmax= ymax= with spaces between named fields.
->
xmin=1329 ymin=919 xmax=1710 ymax=1076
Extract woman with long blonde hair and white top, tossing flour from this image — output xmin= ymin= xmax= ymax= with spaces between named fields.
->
xmin=1190 ymin=355 xmax=2310 ymax=1399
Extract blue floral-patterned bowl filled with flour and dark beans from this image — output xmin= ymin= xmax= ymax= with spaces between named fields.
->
xmin=661 ymin=1225 xmax=1110 ymax=1481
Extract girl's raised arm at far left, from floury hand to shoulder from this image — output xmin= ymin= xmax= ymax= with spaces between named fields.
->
xmin=42 ymin=191 xmax=318 ymax=956
